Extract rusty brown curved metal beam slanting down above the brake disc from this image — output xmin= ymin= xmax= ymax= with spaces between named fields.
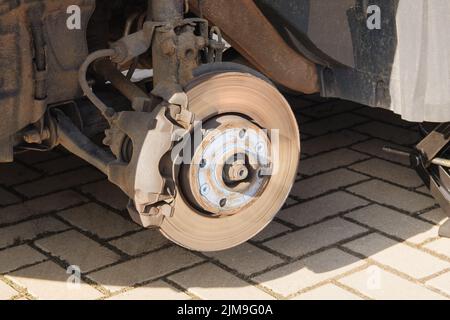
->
xmin=189 ymin=0 xmax=320 ymax=93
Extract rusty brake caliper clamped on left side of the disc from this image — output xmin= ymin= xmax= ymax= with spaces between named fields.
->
xmin=108 ymin=106 xmax=179 ymax=227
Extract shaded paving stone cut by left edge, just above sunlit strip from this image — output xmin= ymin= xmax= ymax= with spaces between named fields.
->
xmin=0 ymin=245 xmax=47 ymax=274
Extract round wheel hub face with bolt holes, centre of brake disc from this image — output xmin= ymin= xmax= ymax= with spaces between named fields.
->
xmin=184 ymin=115 xmax=271 ymax=217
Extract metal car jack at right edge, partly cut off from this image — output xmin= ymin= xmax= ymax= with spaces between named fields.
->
xmin=384 ymin=123 xmax=450 ymax=238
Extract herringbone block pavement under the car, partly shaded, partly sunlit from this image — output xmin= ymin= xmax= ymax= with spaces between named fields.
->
xmin=0 ymin=96 xmax=450 ymax=299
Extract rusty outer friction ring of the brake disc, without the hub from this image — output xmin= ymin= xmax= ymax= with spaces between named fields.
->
xmin=161 ymin=72 xmax=300 ymax=251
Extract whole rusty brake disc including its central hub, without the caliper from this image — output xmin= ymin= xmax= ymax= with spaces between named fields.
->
xmin=161 ymin=72 xmax=300 ymax=251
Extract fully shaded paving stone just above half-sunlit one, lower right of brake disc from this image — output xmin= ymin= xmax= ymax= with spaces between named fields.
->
xmin=264 ymin=218 xmax=367 ymax=257
